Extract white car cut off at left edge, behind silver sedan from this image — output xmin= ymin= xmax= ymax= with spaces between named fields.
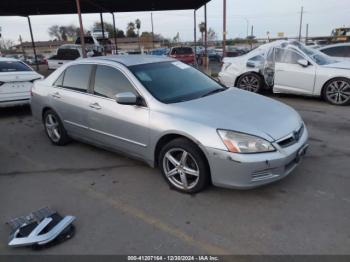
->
xmin=0 ymin=58 xmax=43 ymax=107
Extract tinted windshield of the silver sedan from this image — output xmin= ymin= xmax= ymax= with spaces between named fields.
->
xmin=129 ymin=61 xmax=226 ymax=104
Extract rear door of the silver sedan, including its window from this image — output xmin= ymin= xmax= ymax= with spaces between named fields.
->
xmin=50 ymin=64 xmax=93 ymax=137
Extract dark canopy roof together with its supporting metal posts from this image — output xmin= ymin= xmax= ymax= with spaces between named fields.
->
xmin=0 ymin=0 xmax=213 ymax=69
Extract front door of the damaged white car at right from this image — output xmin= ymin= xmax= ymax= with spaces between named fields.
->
xmin=273 ymin=48 xmax=316 ymax=94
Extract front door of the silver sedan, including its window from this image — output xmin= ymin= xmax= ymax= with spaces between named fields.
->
xmin=89 ymin=65 xmax=149 ymax=158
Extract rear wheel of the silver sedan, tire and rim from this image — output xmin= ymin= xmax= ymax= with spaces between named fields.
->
xmin=43 ymin=110 xmax=70 ymax=146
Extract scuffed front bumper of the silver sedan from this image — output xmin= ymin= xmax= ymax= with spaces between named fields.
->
xmin=206 ymin=128 xmax=308 ymax=189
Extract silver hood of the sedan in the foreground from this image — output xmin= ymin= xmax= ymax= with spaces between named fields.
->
xmin=165 ymin=88 xmax=302 ymax=141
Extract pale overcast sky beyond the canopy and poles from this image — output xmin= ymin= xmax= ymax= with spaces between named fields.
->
xmin=0 ymin=0 xmax=350 ymax=42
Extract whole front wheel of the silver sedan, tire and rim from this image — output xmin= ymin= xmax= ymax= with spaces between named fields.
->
xmin=158 ymin=138 xmax=210 ymax=193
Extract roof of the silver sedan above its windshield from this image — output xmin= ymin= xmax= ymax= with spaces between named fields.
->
xmin=89 ymin=55 xmax=177 ymax=66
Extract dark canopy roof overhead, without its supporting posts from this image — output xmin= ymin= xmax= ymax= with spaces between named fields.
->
xmin=0 ymin=0 xmax=210 ymax=16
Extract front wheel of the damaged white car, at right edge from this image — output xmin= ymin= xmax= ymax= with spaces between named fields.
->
xmin=322 ymin=77 xmax=350 ymax=106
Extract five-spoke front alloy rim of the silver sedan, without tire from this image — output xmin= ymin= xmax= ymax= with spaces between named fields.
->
xmin=163 ymin=148 xmax=200 ymax=190
